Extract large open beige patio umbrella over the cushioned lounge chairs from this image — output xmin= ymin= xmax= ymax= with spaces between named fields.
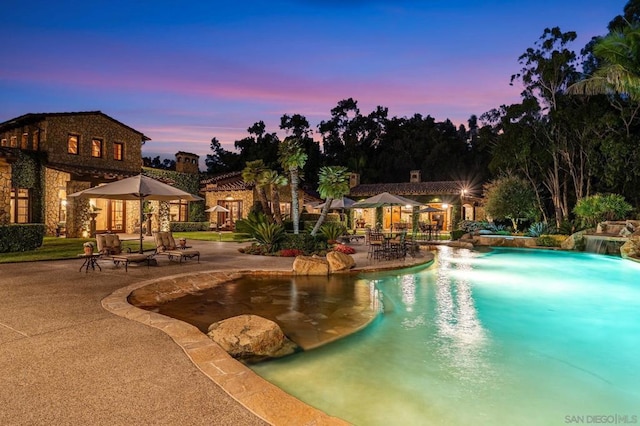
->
xmin=68 ymin=174 xmax=202 ymax=253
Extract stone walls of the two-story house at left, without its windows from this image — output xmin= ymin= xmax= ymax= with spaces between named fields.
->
xmin=0 ymin=111 xmax=148 ymax=237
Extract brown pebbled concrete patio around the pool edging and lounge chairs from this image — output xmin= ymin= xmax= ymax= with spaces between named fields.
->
xmin=0 ymin=241 xmax=431 ymax=425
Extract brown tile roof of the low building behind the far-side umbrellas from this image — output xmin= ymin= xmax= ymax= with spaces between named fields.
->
xmin=349 ymin=181 xmax=464 ymax=197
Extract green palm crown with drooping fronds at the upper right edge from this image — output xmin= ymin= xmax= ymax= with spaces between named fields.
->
xmin=568 ymin=23 xmax=640 ymax=101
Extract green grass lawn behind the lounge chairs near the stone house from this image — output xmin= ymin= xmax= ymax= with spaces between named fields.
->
xmin=0 ymin=232 xmax=255 ymax=263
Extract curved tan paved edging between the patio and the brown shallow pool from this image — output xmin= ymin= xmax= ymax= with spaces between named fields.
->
xmin=102 ymin=271 xmax=352 ymax=425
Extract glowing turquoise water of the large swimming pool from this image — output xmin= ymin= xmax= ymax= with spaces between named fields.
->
xmin=252 ymin=247 xmax=640 ymax=425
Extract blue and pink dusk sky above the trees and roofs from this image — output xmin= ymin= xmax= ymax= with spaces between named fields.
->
xmin=0 ymin=0 xmax=627 ymax=170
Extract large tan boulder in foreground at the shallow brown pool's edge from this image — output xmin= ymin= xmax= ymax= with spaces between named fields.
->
xmin=207 ymin=315 xmax=298 ymax=361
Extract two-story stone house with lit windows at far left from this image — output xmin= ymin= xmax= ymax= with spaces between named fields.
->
xmin=0 ymin=111 xmax=150 ymax=237
